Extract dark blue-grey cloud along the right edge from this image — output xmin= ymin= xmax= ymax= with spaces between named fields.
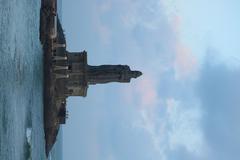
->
xmin=197 ymin=50 xmax=240 ymax=160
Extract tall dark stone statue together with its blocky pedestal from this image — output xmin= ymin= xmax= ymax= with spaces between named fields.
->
xmin=55 ymin=51 xmax=142 ymax=97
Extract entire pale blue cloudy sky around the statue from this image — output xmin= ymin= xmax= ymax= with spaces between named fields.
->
xmin=62 ymin=0 xmax=240 ymax=160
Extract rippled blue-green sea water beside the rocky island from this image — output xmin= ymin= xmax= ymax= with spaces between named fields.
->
xmin=0 ymin=0 xmax=62 ymax=160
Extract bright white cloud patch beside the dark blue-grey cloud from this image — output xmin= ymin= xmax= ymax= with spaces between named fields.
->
xmin=167 ymin=99 xmax=204 ymax=155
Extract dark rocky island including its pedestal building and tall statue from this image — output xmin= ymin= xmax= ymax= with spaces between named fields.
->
xmin=40 ymin=0 xmax=142 ymax=156
